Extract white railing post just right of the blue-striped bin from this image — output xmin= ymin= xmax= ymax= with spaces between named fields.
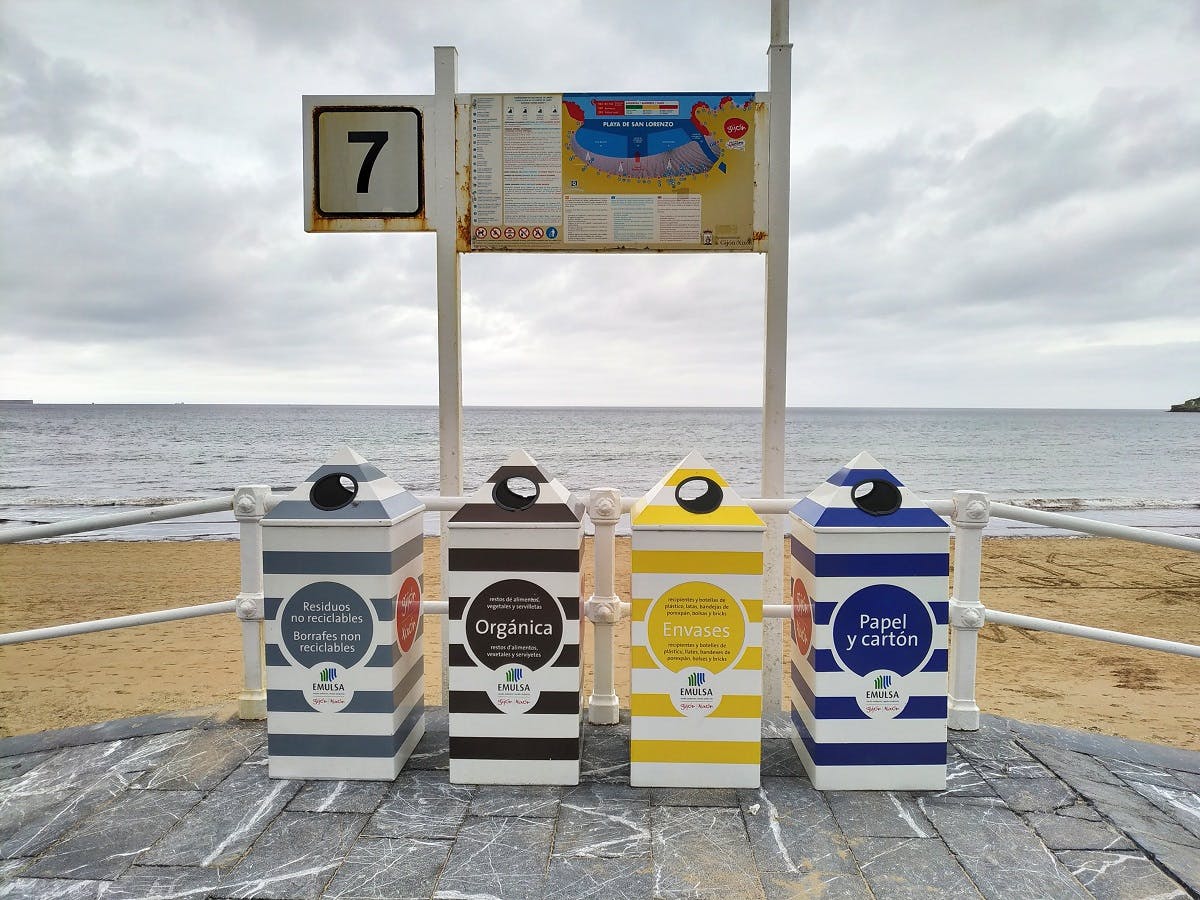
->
xmin=948 ymin=491 xmax=991 ymax=731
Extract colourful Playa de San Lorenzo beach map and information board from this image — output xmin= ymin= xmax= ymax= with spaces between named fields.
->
xmin=469 ymin=94 xmax=762 ymax=251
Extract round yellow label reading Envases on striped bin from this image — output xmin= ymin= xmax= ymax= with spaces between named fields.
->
xmin=646 ymin=581 xmax=746 ymax=672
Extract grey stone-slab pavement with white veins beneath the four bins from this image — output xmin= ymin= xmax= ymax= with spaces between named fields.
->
xmin=0 ymin=708 xmax=1200 ymax=900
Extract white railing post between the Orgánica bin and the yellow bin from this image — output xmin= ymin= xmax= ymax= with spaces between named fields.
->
xmin=583 ymin=487 xmax=620 ymax=725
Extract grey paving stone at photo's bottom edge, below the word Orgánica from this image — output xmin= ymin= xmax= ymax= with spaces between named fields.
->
xmin=434 ymin=816 xmax=553 ymax=900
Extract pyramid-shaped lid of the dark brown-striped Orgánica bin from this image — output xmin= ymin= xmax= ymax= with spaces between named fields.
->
xmin=450 ymin=450 xmax=583 ymax=528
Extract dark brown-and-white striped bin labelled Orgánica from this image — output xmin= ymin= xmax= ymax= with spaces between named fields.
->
xmin=446 ymin=450 xmax=583 ymax=785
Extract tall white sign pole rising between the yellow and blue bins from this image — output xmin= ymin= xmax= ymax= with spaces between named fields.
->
xmin=762 ymin=0 xmax=792 ymax=712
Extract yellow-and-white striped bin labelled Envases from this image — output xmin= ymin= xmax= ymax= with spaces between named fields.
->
xmin=629 ymin=451 xmax=766 ymax=787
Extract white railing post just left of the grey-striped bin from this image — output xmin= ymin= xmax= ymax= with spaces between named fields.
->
xmin=233 ymin=485 xmax=271 ymax=719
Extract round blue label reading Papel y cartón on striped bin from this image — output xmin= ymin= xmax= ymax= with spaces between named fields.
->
xmin=833 ymin=584 xmax=934 ymax=676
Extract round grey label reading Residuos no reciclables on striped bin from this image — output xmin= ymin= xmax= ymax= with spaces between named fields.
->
xmin=280 ymin=581 xmax=374 ymax=670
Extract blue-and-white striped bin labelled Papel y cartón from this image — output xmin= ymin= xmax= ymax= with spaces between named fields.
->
xmin=788 ymin=452 xmax=950 ymax=791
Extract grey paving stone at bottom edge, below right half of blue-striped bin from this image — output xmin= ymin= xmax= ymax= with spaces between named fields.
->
xmin=850 ymin=838 xmax=979 ymax=900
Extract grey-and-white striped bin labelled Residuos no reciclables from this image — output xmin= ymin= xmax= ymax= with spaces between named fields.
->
xmin=263 ymin=448 xmax=425 ymax=781
